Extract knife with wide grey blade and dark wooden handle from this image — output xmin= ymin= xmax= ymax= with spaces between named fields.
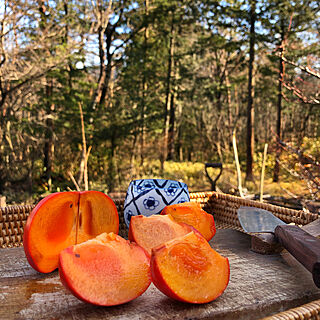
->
xmin=237 ymin=207 xmax=320 ymax=288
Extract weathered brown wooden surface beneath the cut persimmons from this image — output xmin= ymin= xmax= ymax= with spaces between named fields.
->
xmin=0 ymin=230 xmax=320 ymax=320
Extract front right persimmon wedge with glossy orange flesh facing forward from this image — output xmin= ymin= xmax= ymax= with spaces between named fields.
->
xmin=150 ymin=232 xmax=230 ymax=304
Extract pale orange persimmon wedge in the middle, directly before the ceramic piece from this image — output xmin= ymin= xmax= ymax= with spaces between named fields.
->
xmin=128 ymin=215 xmax=194 ymax=255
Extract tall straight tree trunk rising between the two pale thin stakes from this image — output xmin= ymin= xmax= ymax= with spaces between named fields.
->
xmin=246 ymin=0 xmax=256 ymax=181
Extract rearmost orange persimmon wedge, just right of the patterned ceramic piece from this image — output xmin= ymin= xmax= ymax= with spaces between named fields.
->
xmin=161 ymin=202 xmax=216 ymax=241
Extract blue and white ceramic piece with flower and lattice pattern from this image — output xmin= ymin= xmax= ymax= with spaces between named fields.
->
xmin=124 ymin=179 xmax=190 ymax=227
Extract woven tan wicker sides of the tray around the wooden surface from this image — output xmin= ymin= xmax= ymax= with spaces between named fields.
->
xmin=0 ymin=192 xmax=320 ymax=320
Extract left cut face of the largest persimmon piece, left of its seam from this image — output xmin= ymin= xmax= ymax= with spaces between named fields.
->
xmin=24 ymin=192 xmax=79 ymax=272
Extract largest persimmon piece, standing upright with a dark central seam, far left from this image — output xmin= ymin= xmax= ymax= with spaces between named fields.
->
xmin=23 ymin=191 xmax=119 ymax=273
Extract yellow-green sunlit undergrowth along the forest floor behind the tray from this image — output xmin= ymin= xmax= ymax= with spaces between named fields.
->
xmin=3 ymin=159 xmax=309 ymax=204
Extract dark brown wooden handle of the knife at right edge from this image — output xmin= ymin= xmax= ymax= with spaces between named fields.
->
xmin=275 ymin=225 xmax=320 ymax=288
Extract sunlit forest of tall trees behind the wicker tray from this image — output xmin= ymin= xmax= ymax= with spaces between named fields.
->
xmin=0 ymin=0 xmax=320 ymax=203
